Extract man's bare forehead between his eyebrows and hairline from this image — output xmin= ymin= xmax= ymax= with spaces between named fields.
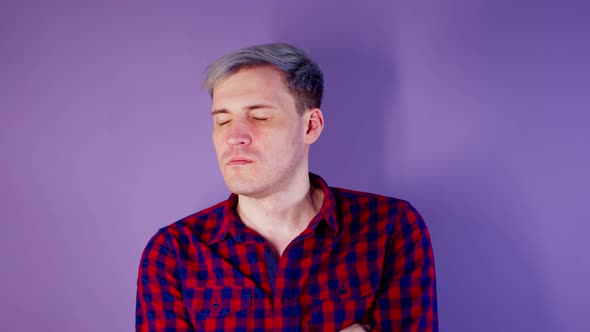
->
xmin=212 ymin=66 xmax=293 ymax=108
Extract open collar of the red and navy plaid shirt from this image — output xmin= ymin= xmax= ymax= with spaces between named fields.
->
xmin=206 ymin=172 xmax=340 ymax=244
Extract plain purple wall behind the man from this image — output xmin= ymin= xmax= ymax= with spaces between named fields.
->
xmin=0 ymin=0 xmax=590 ymax=332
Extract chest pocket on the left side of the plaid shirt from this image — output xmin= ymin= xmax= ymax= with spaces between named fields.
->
xmin=183 ymin=286 xmax=252 ymax=331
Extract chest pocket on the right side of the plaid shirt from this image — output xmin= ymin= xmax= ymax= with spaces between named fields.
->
xmin=309 ymin=269 xmax=380 ymax=331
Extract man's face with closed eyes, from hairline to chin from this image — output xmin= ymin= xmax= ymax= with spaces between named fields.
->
xmin=212 ymin=66 xmax=308 ymax=198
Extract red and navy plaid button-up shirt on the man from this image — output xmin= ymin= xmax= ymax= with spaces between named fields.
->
xmin=136 ymin=173 xmax=438 ymax=332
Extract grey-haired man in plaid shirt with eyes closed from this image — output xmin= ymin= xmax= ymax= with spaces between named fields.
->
xmin=136 ymin=44 xmax=438 ymax=331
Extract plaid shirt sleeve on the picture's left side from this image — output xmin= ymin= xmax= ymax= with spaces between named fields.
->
xmin=135 ymin=231 xmax=194 ymax=332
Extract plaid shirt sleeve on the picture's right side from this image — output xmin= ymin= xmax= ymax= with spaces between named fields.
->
xmin=372 ymin=202 xmax=438 ymax=332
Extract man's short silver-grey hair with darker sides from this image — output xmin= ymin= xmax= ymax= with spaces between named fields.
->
xmin=204 ymin=43 xmax=324 ymax=113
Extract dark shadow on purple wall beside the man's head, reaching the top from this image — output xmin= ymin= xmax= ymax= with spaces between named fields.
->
xmin=272 ymin=2 xmax=399 ymax=195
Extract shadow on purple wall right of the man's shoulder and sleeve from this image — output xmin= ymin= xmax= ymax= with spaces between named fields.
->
xmin=405 ymin=157 xmax=559 ymax=332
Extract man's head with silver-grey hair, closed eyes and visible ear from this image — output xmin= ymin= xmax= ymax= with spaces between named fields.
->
xmin=205 ymin=44 xmax=324 ymax=198
